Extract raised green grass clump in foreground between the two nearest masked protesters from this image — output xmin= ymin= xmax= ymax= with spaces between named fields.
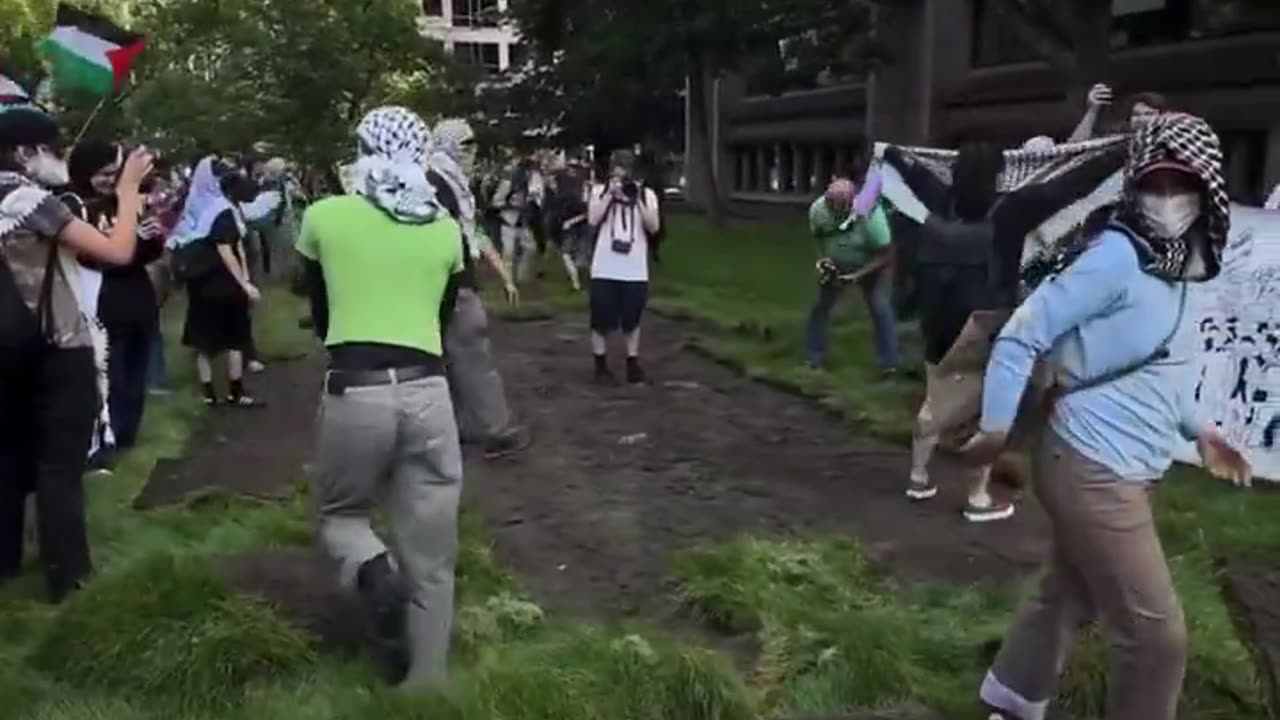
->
xmin=676 ymin=538 xmax=1004 ymax=716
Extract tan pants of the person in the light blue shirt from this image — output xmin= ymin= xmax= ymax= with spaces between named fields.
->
xmin=982 ymin=430 xmax=1187 ymax=720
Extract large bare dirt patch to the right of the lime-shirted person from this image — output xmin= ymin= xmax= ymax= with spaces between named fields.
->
xmin=467 ymin=310 xmax=1044 ymax=616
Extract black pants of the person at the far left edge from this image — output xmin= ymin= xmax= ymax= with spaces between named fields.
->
xmin=0 ymin=348 xmax=97 ymax=601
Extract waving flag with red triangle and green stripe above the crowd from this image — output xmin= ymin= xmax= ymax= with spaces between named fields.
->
xmin=38 ymin=5 xmax=146 ymax=97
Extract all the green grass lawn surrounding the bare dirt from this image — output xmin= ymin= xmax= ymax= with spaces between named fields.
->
xmin=0 ymin=218 xmax=1280 ymax=720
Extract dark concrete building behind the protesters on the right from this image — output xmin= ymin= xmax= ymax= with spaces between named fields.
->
xmin=686 ymin=0 xmax=1280 ymax=205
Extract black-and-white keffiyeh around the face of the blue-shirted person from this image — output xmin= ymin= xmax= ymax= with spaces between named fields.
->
xmin=1119 ymin=113 xmax=1231 ymax=282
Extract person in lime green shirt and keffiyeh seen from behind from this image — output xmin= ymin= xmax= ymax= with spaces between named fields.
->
xmin=297 ymin=108 xmax=463 ymax=689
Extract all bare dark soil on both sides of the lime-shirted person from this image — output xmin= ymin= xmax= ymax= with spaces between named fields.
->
xmin=145 ymin=308 xmax=1044 ymax=655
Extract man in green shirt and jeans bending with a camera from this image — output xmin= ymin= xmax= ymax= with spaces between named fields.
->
xmin=805 ymin=179 xmax=899 ymax=373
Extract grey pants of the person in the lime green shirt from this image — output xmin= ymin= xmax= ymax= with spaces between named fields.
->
xmin=316 ymin=378 xmax=462 ymax=685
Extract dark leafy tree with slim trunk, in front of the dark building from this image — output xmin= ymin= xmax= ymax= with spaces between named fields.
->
xmin=512 ymin=0 xmax=879 ymax=223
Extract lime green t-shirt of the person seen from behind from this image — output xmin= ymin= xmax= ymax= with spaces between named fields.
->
xmin=297 ymin=195 xmax=462 ymax=355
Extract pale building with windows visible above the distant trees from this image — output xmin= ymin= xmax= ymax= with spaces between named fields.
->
xmin=419 ymin=0 xmax=526 ymax=73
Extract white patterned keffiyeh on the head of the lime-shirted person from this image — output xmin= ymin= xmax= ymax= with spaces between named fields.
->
xmin=352 ymin=106 xmax=440 ymax=224
